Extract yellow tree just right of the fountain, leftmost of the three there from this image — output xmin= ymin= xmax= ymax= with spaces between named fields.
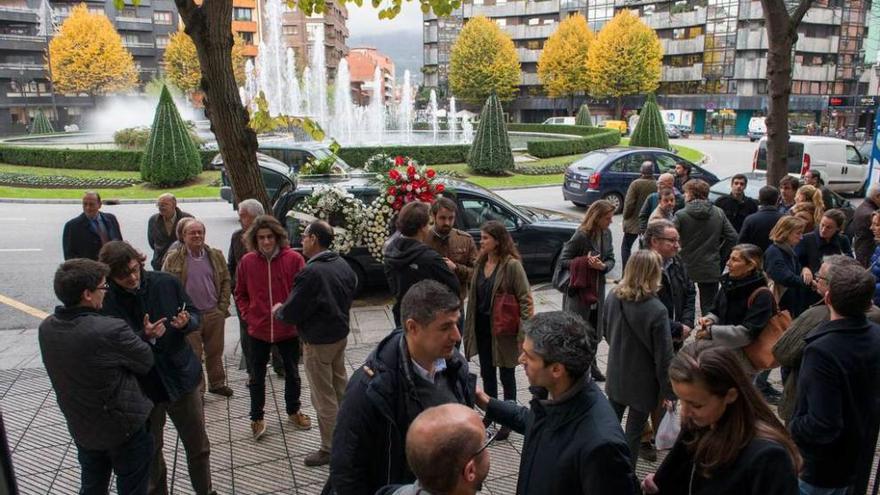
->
xmin=449 ymin=16 xmax=520 ymax=104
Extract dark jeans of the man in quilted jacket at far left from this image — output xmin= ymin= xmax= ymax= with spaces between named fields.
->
xmin=76 ymin=425 xmax=153 ymax=495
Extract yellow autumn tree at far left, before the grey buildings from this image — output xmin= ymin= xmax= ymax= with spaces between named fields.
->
xmin=49 ymin=3 xmax=138 ymax=96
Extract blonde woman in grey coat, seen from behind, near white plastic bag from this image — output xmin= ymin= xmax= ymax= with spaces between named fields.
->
xmin=604 ymin=250 xmax=675 ymax=468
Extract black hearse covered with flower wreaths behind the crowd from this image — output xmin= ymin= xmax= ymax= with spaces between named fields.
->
xmin=273 ymin=176 xmax=581 ymax=292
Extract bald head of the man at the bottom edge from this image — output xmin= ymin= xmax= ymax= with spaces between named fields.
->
xmin=376 ymin=404 xmax=494 ymax=495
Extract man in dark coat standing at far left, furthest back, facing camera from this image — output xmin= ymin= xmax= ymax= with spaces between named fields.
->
xmin=61 ymin=191 xmax=122 ymax=260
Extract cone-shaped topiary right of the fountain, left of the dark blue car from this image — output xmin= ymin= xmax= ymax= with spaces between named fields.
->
xmin=468 ymin=93 xmax=513 ymax=175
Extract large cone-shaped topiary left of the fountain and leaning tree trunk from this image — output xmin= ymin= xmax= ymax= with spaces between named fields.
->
xmin=141 ymin=86 xmax=202 ymax=187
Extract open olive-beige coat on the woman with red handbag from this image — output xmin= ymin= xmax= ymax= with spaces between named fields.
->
xmin=464 ymin=257 xmax=535 ymax=368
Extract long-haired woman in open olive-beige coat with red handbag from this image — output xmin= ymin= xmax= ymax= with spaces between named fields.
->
xmin=464 ymin=220 xmax=534 ymax=440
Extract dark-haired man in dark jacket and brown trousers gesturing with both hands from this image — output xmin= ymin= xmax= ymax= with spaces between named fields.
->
xmin=99 ymin=241 xmax=214 ymax=495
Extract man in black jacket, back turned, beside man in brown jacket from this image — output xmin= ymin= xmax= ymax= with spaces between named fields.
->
xmin=385 ymin=201 xmax=461 ymax=327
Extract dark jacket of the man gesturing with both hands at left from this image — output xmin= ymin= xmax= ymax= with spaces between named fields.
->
xmin=101 ymin=270 xmax=202 ymax=402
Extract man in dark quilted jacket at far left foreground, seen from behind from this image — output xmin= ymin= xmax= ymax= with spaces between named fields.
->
xmin=38 ymin=259 xmax=156 ymax=495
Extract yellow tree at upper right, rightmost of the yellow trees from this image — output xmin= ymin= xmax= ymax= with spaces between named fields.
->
xmin=587 ymin=10 xmax=663 ymax=118
